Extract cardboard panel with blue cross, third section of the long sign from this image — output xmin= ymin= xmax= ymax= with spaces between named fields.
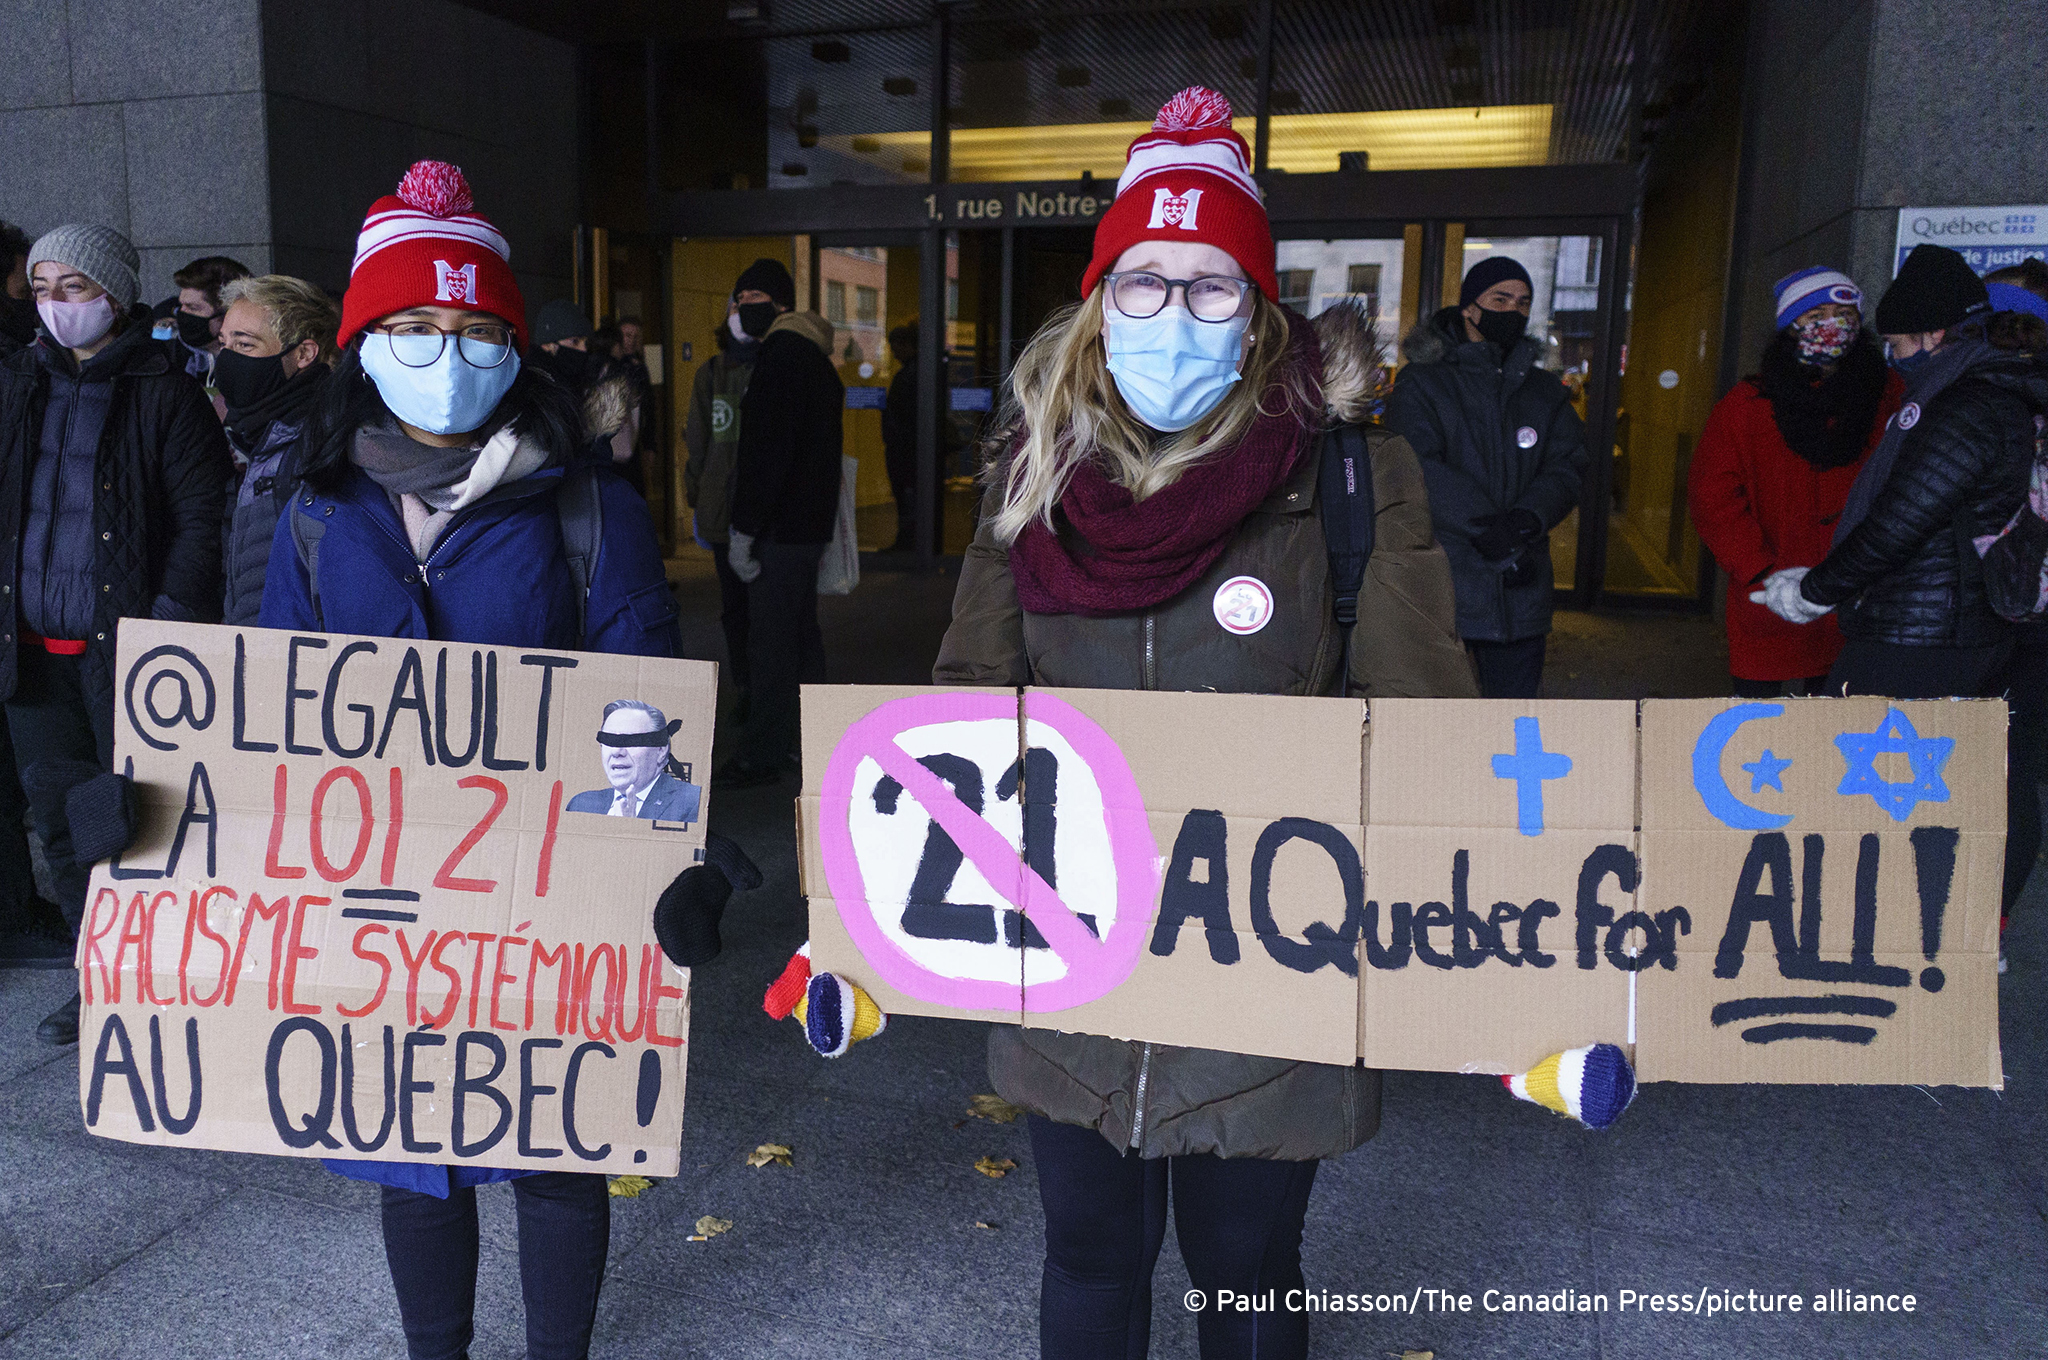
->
xmin=1360 ymin=698 xmax=1661 ymax=1073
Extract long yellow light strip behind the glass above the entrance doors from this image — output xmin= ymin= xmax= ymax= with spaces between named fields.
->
xmin=819 ymin=104 xmax=1550 ymax=182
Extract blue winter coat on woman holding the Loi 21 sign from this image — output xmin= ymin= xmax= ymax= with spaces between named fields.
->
xmin=262 ymin=454 xmax=682 ymax=1198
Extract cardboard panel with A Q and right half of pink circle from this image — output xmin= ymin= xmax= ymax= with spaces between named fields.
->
xmin=1022 ymin=690 xmax=1366 ymax=1063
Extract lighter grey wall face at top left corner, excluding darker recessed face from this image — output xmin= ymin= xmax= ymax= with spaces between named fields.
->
xmin=0 ymin=0 xmax=270 ymax=299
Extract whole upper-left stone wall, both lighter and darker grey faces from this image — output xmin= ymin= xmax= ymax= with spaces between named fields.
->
xmin=0 ymin=0 xmax=578 ymax=307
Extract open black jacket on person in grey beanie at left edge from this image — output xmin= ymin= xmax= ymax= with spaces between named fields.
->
xmin=0 ymin=328 xmax=233 ymax=713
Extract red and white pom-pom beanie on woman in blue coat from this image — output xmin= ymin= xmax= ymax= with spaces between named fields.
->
xmin=340 ymin=160 xmax=526 ymax=348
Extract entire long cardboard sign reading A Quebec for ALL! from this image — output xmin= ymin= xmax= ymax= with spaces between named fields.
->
xmin=799 ymin=686 xmax=2005 ymax=1086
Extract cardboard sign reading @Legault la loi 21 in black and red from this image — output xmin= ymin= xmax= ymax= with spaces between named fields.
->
xmin=78 ymin=619 xmax=717 ymax=1176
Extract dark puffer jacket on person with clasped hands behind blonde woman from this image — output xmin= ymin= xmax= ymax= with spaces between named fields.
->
xmin=1384 ymin=307 xmax=1591 ymax=643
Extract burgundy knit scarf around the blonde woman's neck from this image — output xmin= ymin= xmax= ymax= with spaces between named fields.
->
xmin=1010 ymin=313 xmax=1323 ymax=614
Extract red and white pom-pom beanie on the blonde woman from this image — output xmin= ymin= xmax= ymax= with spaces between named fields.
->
xmin=1081 ymin=86 xmax=1280 ymax=299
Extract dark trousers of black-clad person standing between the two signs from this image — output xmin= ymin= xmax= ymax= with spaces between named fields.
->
xmin=739 ymin=539 xmax=825 ymax=766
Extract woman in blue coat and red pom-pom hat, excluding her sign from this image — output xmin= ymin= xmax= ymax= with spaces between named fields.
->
xmin=262 ymin=160 xmax=696 ymax=1360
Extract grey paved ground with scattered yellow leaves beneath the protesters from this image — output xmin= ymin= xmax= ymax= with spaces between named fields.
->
xmin=0 ymin=569 xmax=2048 ymax=1360
